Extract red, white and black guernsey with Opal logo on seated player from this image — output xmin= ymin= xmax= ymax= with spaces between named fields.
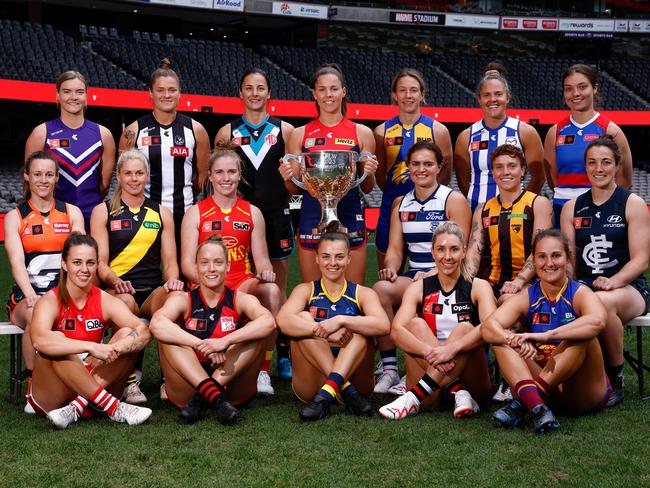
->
xmin=418 ymin=275 xmax=480 ymax=341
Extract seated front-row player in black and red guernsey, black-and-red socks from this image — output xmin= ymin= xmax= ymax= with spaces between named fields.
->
xmin=151 ymin=235 xmax=275 ymax=424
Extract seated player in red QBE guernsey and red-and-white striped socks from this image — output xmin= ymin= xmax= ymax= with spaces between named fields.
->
xmin=27 ymin=234 xmax=151 ymax=429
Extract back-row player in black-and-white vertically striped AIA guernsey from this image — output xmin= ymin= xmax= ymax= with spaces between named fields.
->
xmin=119 ymin=58 xmax=210 ymax=249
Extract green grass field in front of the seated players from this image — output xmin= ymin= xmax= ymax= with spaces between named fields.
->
xmin=0 ymin=242 xmax=650 ymax=487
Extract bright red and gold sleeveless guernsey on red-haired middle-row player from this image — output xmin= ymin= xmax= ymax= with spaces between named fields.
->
xmin=198 ymin=198 xmax=255 ymax=290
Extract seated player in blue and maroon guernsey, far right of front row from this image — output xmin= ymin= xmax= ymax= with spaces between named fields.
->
xmin=481 ymin=229 xmax=611 ymax=433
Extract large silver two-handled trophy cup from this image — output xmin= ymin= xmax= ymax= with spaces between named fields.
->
xmin=284 ymin=151 xmax=372 ymax=234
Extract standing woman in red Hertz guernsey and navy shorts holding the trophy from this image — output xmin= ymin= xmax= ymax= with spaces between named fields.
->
xmin=280 ymin=64 xmax=379 ymax=283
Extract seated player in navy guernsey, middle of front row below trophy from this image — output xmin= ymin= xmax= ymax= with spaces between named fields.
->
xmin=277 ymin=222 xmax=390 ymax=420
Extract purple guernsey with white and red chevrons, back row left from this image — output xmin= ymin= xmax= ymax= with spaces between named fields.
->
xmin=45 ymin=118 xmax=104 ymax=229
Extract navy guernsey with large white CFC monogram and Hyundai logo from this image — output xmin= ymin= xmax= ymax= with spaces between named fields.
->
xmin=573 ymin=186 xmax=643 ymax=286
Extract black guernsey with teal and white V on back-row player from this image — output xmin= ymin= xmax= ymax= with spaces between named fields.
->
xmin=230 ymin=115 xmax=288 ymax=212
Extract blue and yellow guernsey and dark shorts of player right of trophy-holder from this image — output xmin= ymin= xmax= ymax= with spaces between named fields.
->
xmin=376 ymin=115 xmax=435 ymax=253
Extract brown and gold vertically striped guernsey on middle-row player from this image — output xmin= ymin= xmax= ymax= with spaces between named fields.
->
xmin=478 ymin=191 xmax=537 ymax=287
